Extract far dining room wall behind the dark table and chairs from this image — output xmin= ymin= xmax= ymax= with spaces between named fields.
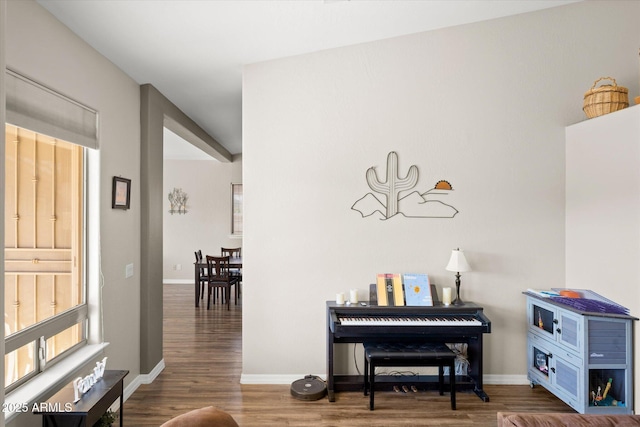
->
xmin=162 ymin=155 xmax=242 ymax=283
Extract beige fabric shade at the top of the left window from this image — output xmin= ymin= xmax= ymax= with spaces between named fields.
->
xmin=5 ymin=70 xmax=98 ymax=149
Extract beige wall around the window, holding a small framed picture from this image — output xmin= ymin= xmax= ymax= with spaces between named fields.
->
xmin=6 ymin=1 xmax=140 ymax=412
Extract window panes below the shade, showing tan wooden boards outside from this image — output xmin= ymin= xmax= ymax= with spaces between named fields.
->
xmin=4 ymin=125 xmax=88 ymax=391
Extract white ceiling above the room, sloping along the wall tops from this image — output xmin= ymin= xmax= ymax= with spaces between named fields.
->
xmin=37 ymin=0 xmax=577 ymax=158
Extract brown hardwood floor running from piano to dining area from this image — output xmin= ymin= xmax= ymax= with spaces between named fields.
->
xmin=124 ymin=285 xmax=574 ymax=427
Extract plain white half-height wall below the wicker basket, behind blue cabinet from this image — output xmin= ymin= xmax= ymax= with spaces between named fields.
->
xmin=566 ymin=106 xmax=640 ymax=413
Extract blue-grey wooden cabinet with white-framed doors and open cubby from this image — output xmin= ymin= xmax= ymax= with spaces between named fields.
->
xmin=525 ymin=292 xmax=638 ymax=414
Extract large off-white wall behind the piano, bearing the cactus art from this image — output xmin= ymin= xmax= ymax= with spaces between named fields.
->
xmin=243 ymin=1 xmax=640 ymax=383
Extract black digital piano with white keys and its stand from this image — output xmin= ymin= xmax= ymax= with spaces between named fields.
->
xmin=327 ymin=301 xmax=491 ymax=402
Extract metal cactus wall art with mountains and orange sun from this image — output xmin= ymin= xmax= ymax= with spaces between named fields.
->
xmin=351 ymin=151 xmax=458 ymax=220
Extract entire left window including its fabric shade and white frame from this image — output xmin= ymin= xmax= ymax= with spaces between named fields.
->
xmin=2 ymin=70 xmax=98 ymax=402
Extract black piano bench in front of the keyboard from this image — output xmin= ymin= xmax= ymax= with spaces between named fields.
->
xmin=363 ymin=343 xmax=456 ymax=411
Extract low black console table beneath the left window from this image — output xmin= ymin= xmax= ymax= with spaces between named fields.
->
xmin=34 ymin=370 xmax=129 ymax=427
